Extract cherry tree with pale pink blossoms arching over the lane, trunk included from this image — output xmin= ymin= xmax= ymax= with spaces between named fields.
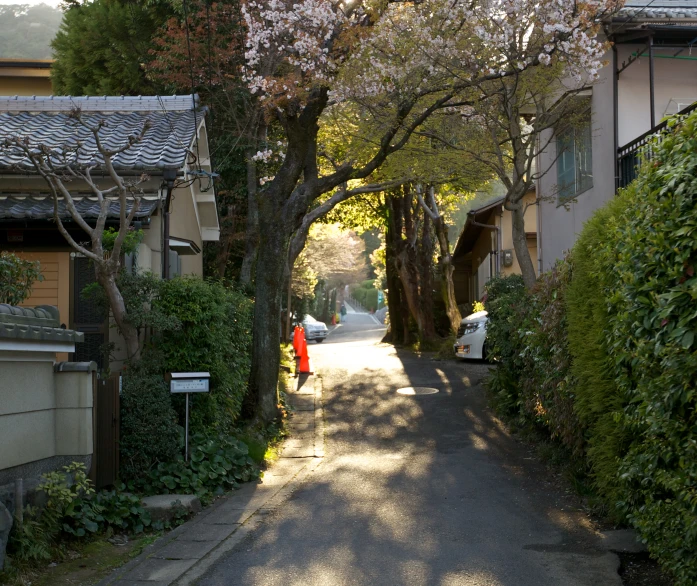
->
xmin=242 ymin=0 xmax=620 ymax=420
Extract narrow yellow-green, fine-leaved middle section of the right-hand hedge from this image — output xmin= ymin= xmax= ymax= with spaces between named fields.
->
xmin=566 ymin=193 xmax=633 ymax=504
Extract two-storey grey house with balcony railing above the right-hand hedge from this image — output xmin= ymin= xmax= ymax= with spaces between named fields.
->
xmin=537 ymin=0 xmax=697 ymax=271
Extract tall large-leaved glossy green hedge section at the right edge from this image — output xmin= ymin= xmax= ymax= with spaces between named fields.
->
xmin=606 ymin=114 xmax=697 ymax=586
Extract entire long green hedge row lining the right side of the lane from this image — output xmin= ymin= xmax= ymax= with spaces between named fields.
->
xmin=486 ymin=114 xmax=697 ymax=586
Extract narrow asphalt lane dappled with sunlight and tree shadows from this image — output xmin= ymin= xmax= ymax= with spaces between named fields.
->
xmin=199 ymin=314 xmax=621 ymax=586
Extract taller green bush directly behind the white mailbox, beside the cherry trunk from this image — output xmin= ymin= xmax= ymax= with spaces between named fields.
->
xmin=152 ymin=277 xmax=252 ymax=433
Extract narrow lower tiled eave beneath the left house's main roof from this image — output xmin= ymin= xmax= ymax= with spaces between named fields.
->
xmin=0 ymin=193 xmax=158 ymax=220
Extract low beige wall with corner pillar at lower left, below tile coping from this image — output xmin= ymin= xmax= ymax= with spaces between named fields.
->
xmin=0 ymin=342 xmax=93 ymax=486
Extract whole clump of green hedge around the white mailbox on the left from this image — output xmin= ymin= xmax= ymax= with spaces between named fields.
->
xmin=119 ymin=274 xmax=252 ymax=480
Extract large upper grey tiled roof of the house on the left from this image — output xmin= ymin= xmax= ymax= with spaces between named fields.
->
xmin=0 ymin=96 xmax=204 ymax=172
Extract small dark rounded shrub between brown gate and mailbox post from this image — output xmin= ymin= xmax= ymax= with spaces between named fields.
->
xmin=120 ymin=359 xmax=180 ymax=480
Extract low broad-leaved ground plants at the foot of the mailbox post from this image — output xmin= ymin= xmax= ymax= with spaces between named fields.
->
xmin=128 ymin=434 xmax=259 ymax=500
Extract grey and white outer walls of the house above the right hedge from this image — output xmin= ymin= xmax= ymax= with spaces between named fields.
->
xmin=538 ymin=45 xmax=697 ymax=271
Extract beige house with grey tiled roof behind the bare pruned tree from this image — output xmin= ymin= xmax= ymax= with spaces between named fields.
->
xmin=0 ymin=95 xmax=220 ymax=364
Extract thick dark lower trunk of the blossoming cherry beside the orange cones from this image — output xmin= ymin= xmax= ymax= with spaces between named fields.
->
xmin=249 ymin=212 xmax=290 ymax=422
